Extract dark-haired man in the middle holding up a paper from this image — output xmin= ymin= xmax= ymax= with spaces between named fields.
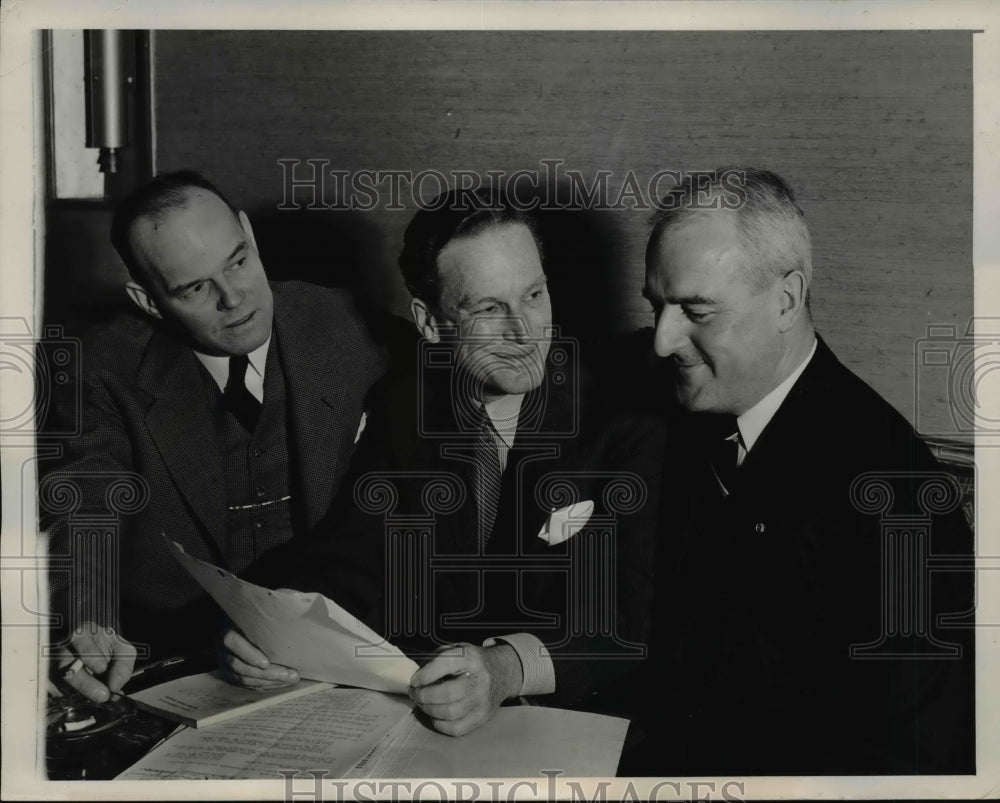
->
xmin=227 ymin=191 xmax=659 ymax=735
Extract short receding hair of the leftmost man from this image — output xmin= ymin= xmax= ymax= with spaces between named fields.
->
xmin=111 ymin=170 xmax=239 ymax=288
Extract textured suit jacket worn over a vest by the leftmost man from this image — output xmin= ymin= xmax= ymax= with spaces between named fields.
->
xmin=42 ymin=282 xmax=382 ymax=653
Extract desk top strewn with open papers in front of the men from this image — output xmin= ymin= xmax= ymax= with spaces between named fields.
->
xmin=50 ymin=660 xmax=628 ymax=780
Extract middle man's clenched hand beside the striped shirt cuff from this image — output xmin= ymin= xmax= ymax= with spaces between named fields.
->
xmin=410 ymin=644 xmax=524 ymax=736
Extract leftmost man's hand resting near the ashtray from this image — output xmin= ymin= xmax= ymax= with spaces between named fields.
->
xmin=53 ymin=622 xmax=136 ymax=703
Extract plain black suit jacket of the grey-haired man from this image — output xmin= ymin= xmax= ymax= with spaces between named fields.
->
xmin=623 ymin=340 xmax=975 ymax=775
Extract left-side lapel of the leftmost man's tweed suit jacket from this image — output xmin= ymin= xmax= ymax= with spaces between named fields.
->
xmin=137 ymin=330 xmax=226 ymax=548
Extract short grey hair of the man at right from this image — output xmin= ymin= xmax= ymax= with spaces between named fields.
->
xmin=647 ymin=167 xmax=812 ymax=289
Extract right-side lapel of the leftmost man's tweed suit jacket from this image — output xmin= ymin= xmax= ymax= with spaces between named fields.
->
xmin=272 ymin=285 xmax=360 ymax=527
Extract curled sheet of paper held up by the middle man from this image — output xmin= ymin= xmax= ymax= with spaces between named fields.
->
xmin=170 ymin=541 xmax=417 ymax=694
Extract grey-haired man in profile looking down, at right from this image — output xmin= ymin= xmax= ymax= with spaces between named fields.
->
xmin=625 ymin=169 xmax=975 ymax=775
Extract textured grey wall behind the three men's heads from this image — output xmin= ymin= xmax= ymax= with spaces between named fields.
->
xmin=155 ymin=31 xmax=972 ymax=440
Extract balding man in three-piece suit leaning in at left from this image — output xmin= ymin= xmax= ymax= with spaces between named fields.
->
xmin=42 ymin=171 xmax=381 ymax=700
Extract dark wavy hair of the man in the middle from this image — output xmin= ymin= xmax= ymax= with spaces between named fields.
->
xmin=399 ymin=189 xmax=542 ymax=311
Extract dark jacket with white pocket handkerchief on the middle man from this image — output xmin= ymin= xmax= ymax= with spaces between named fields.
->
xmin=280 ymin=358 xmax=662 ymax=710
